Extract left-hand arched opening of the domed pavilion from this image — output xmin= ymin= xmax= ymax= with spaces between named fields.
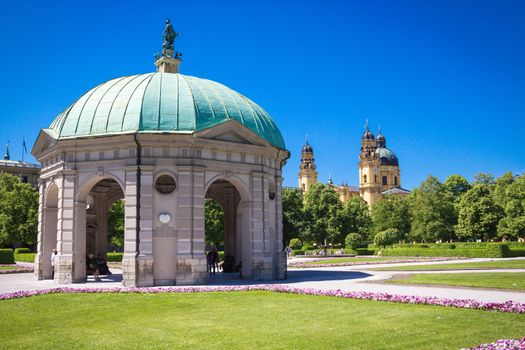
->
xmin=85 ymin=179 xmax=125 ymax=280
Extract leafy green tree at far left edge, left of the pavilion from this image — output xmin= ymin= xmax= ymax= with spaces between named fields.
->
xmin=0 ymin=173 xmax=38 ymax=247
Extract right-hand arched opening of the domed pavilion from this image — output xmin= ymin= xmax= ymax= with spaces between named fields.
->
xmin=205 ymin=180 xmax=243 ymax=273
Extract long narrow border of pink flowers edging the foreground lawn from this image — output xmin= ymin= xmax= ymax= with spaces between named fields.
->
xmin=0 ymin=284 xmax=525 ymax=314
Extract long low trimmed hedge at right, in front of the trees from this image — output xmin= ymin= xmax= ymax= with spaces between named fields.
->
xmin=381 ymin=243 xmax=525 ymax=258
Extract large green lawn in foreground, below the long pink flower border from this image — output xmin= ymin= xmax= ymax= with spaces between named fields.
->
xmin=0 ymin=291 xmax=525 ymax=349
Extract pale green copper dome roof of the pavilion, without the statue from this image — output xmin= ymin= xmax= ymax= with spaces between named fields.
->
xmin=49 ymin=72 xmax=286 ymax=150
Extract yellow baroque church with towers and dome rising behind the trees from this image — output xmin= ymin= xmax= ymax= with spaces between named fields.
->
xmin=299 ymin=123 xmax=410 ymax=208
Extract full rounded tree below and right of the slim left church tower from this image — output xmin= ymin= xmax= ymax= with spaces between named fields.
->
xmin=304 ymin=183 xmax=345 ymax=245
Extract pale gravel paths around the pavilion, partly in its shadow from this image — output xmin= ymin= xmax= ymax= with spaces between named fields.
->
xmin=0 ymin=259 xmax=525 ymax=303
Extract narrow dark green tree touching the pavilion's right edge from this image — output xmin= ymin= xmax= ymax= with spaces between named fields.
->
xmin=282 ymin=188 xmax=305 ymax=246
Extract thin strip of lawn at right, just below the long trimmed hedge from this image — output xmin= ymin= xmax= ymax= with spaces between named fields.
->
xmin=376 ymin=259 xmax=525 ymax=271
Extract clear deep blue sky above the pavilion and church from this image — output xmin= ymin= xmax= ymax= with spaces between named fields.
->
xmin=0 ymin=0 xmax=525 ymax=189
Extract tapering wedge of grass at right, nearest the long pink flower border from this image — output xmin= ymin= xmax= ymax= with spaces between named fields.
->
xmin=385 ymin=272 xmax=525 ymax=290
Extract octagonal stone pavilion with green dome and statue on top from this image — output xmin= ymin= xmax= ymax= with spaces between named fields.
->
xmin=32 ymin=21 xmax=289 ymax=286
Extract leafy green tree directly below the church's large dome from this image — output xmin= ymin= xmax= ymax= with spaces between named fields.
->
xmin=372 ymin=195 xmax=410 ymax=239
